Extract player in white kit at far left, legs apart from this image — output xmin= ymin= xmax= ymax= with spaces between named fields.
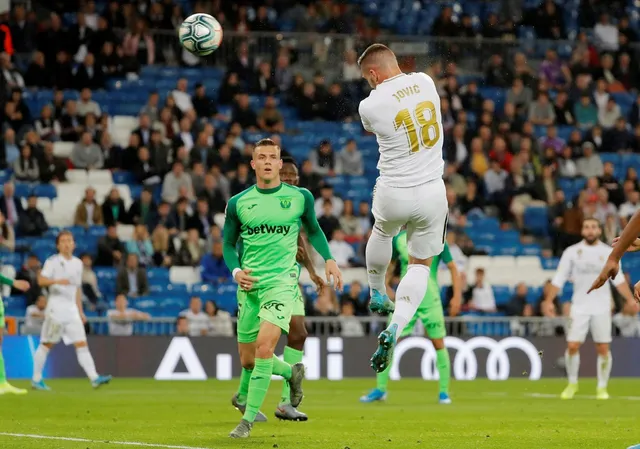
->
xmin=31 ymin=231 xmax=111 ymax=390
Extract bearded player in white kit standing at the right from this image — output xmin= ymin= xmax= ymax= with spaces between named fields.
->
xmin=542 ymin=218 xmax=635 ymax=399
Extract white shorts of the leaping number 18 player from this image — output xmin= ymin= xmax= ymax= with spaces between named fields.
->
xmin=373 ymin=179 xmax=449 ymax=259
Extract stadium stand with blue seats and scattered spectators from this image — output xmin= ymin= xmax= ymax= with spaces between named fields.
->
xmin=0 ymin=0 xmax=640 ymax=331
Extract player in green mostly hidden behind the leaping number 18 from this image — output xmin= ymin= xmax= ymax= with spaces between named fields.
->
xmin=360 ymin=231 xmax=462 ymax=404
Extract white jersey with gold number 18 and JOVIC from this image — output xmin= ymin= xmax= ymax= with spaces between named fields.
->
xmin=358 ymin=73 xmax=444 ymax=187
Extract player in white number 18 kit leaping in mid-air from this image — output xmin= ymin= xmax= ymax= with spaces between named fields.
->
xmin=358 ymin=44 xmax=449 ymax=372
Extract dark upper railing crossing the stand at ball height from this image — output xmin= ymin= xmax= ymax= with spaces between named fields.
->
xmin=139 ymin=30 xmax=640 ymax=72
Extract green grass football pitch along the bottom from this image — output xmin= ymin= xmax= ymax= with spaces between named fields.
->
xmin=0 ymin=379 xmax=640 ymax=449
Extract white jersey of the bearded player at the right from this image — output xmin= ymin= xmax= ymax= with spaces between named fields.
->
xmin=551 ymin=240 xmax=625 ymax=315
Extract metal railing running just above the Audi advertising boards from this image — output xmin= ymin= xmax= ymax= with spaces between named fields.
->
xmin=8 ymin=315 xmax=566 ymax=337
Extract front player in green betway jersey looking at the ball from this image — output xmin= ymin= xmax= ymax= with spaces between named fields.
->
xmin=223 ymin=139 xmax=342 ymax=438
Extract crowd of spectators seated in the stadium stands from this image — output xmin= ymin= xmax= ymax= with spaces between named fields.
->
xmin=0 ymin=0 xmax=640 ymax=335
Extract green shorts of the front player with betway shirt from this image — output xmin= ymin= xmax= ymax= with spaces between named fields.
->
xmin=237 ymin=284 xmax=302 ymax=343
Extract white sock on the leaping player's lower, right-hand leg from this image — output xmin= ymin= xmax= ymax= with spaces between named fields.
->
xmin=390 ymin=264 xmax=429 ymax=335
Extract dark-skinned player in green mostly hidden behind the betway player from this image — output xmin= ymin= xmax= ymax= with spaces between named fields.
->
xmin=231 ymin=158 xmax=325 ymax=422
